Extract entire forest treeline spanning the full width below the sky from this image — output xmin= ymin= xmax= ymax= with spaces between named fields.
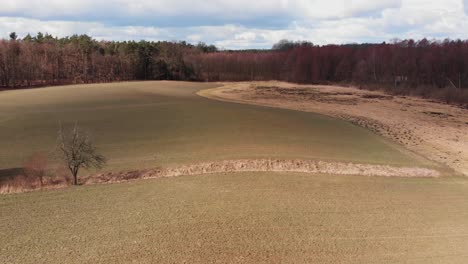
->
xmin=0 ymin=33 xmax=468 ymax=104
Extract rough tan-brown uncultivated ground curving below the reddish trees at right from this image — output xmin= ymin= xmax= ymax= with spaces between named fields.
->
xmin=199 ymin=81 xmax=468 ymax=176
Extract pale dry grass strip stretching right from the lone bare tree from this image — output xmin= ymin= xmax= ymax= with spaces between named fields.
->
xmin=85 ymin=159 xmax=440 ymax=184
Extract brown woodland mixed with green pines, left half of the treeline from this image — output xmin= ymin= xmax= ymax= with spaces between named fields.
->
xmin=0 ymin=33 xmax=216 ymax=88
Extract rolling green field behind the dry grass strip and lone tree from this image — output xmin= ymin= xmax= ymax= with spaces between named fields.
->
xmin=0 ymin=82 xmax=432 ymax=174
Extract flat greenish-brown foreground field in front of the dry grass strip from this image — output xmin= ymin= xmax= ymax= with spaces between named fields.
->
xmin=0 ymin=173 xmax=468 ymax=263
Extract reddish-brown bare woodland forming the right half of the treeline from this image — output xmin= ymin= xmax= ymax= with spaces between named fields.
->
xmin=187 ymin=39 xmax=468 ymax=105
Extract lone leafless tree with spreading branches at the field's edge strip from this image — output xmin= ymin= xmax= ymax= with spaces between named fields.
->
xmin=58 ymin=124 xmax=106 ymax=185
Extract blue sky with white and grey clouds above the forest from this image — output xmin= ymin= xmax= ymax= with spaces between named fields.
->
xmin=0 ymin=0 xmax=468 ymax=49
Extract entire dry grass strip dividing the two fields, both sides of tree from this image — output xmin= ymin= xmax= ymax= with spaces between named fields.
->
xmin=0 ymin=159 xmax=441 ymax=194
